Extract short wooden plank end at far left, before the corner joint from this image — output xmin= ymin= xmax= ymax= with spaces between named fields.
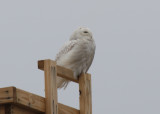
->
xmin=0 ymin=87 xmax=14 ymax=104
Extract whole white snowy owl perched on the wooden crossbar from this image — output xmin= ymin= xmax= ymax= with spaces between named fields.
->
xmin=55 ymin=27 xmax=96 ymax=88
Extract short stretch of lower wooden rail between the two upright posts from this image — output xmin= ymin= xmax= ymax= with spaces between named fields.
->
xmin=58 ymin=103 xmax=80 ymax=114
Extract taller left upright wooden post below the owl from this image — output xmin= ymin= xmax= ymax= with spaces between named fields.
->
xmin=44 ymin=60 xmax=58 ymax=114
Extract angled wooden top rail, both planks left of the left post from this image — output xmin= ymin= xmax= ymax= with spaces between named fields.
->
xmin=0 ymin=87 xmax=45 ymax=112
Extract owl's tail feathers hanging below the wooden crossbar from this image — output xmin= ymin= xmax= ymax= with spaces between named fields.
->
xmin=57 ymin=77 xmax=69 ymax=89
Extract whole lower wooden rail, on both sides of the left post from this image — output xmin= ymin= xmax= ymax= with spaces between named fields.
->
xmin=0 ymin=87 xmax=80 ymax=114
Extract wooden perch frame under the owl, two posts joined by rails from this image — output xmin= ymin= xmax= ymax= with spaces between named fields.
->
xmin=38 ymin=60 xmax=92 ymax=114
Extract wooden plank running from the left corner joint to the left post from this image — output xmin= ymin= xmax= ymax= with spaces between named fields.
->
xmin=16 ymin=89 xmax=45 ymax=112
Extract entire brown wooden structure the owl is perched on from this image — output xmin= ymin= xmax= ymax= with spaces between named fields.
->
xmin=0 ymin=60 xmax=92 ymax=114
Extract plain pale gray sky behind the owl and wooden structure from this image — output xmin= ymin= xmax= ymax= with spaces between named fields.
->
xmin=0 ymin=0 xmax=160 ymax=114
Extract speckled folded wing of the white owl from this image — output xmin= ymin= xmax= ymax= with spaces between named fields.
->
xmin=55 ymin=40 xmax=77 ymax=61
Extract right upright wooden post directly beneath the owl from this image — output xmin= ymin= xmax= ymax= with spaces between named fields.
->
xmin=79 ymin=74 xmax=92 ymax=114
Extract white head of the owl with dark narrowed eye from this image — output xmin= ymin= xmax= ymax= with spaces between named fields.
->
xmin=70 ymin=27 xmax=92 ymax=40
